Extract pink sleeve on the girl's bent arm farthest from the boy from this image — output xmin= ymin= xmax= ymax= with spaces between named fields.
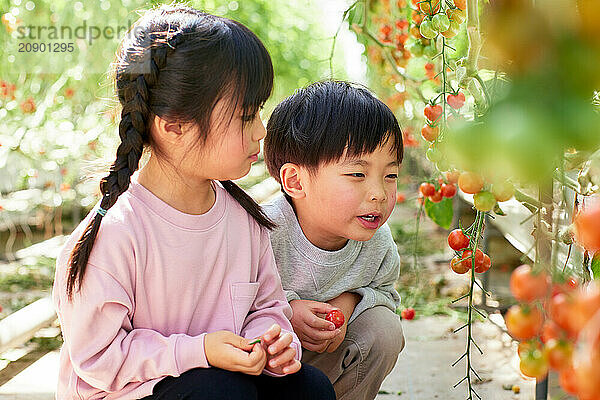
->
xmin=59 ymin=264 xmax=208 ymax=392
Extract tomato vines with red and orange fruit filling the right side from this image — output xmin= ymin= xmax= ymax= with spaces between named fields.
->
xmin=330 ymin=0 xmax=600 ymax=400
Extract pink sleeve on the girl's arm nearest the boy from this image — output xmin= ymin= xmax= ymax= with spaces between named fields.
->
xmin=240 ymin=229 xmax=302 ymax=376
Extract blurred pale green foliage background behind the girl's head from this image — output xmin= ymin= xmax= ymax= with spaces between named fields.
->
xmin=0 ymin=0 xmax=345 ymax=222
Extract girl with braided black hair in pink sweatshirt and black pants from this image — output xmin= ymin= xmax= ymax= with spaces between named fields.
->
xmin=53 ymin=5 xmax=335 ymax=400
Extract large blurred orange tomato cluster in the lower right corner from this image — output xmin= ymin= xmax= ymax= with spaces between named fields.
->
xmin=504 ymin=265 xmax=600 ymax=400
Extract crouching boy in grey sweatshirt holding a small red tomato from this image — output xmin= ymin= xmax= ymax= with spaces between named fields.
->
xmin=264 ymin=81 xmax=404 ymax=400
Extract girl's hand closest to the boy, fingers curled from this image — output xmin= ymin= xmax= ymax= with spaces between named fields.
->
xmin=262 ymin=324 xmax=302 ymax=375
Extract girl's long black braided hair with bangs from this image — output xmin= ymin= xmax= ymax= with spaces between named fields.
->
xmin=67 ymin=4 xmax=274 ymax=297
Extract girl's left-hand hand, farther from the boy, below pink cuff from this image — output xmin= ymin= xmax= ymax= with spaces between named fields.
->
xmin=204 ymin=331 xmax=267 ymax=375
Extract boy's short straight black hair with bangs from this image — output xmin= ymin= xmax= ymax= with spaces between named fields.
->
xmin=264 ymin=80 xmax=403 ymax=183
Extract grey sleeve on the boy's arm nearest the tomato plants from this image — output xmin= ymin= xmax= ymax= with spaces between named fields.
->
xmin=348 ymin=241 xmax=400 ymax=323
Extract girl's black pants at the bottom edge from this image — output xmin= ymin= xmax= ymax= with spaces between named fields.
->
xmin=142 ymin=364 xmax=335 ymax=400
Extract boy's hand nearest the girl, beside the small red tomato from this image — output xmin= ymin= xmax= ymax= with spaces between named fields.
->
xmin=290 ymin=300 xmax=343 ymax=353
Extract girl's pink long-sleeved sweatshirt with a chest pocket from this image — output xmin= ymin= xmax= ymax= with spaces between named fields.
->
xmin=53 ymin=173 xmax=301 ymax=400
